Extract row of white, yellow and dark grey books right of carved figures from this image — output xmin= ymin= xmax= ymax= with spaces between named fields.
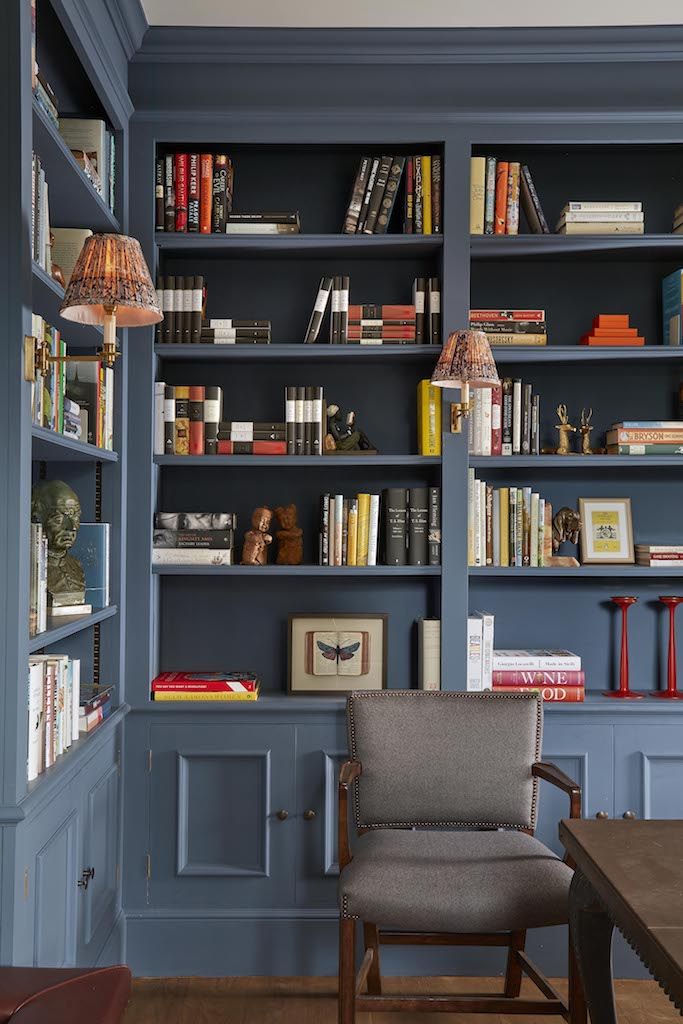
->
xmin=318 ymin=487 xmax=441 ymax=566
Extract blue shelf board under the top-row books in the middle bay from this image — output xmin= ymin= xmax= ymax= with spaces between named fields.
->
xmin=156 ymin=232 xmax=443 ymax=259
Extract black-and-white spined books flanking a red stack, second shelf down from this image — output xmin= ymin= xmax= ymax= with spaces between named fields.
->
xmin=303 ymin=274 xmax=441 ymax=345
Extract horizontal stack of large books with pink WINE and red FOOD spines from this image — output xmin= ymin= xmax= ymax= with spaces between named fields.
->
xmin=493 ymin=650 xmax=586 ymax=703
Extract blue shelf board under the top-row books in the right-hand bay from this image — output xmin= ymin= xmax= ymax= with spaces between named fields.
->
xmin=470 ymin=234 xmax=683 ymax=260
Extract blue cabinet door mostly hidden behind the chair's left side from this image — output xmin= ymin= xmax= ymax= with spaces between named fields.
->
xmin=296 ymin=721 xmax=348 ymax=906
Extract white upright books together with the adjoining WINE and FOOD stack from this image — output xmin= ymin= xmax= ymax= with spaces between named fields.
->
xmin=467 ymin=630 xmax=586 ymax=703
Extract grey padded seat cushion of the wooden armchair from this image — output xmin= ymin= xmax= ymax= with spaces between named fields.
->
xmin=339 ymin=828 xmax=572 ymax=932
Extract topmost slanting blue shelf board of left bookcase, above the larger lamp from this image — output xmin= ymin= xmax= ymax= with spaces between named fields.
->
xmin=33 ymin=99 xmax=121 ymax=231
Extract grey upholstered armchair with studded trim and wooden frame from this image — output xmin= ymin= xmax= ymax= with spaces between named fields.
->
xmin=339 ymin=690 xmax=586 ymax=1024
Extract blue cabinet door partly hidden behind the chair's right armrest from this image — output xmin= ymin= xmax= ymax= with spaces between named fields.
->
xmin=537 ymin=709 xmax=613 ymax=856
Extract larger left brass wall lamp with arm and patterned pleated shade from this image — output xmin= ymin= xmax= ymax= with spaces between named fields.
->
xmin=24 ymin=234 xmax=163 ymax=381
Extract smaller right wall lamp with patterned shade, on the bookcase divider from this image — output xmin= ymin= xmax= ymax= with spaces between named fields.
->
xmin=431 ymin=329 xmax=501 ymax=434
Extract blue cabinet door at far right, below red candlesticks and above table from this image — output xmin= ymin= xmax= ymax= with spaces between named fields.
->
xmin=614 ymin=724 xmax=683 ymax=818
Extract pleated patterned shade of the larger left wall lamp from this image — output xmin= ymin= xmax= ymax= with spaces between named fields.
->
xmin=59 ymin=234 xmax=163 ymax=327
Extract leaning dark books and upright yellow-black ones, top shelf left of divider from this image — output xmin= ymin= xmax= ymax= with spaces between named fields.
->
xmin=343 ymin=156 xmax=442 ymax=234
